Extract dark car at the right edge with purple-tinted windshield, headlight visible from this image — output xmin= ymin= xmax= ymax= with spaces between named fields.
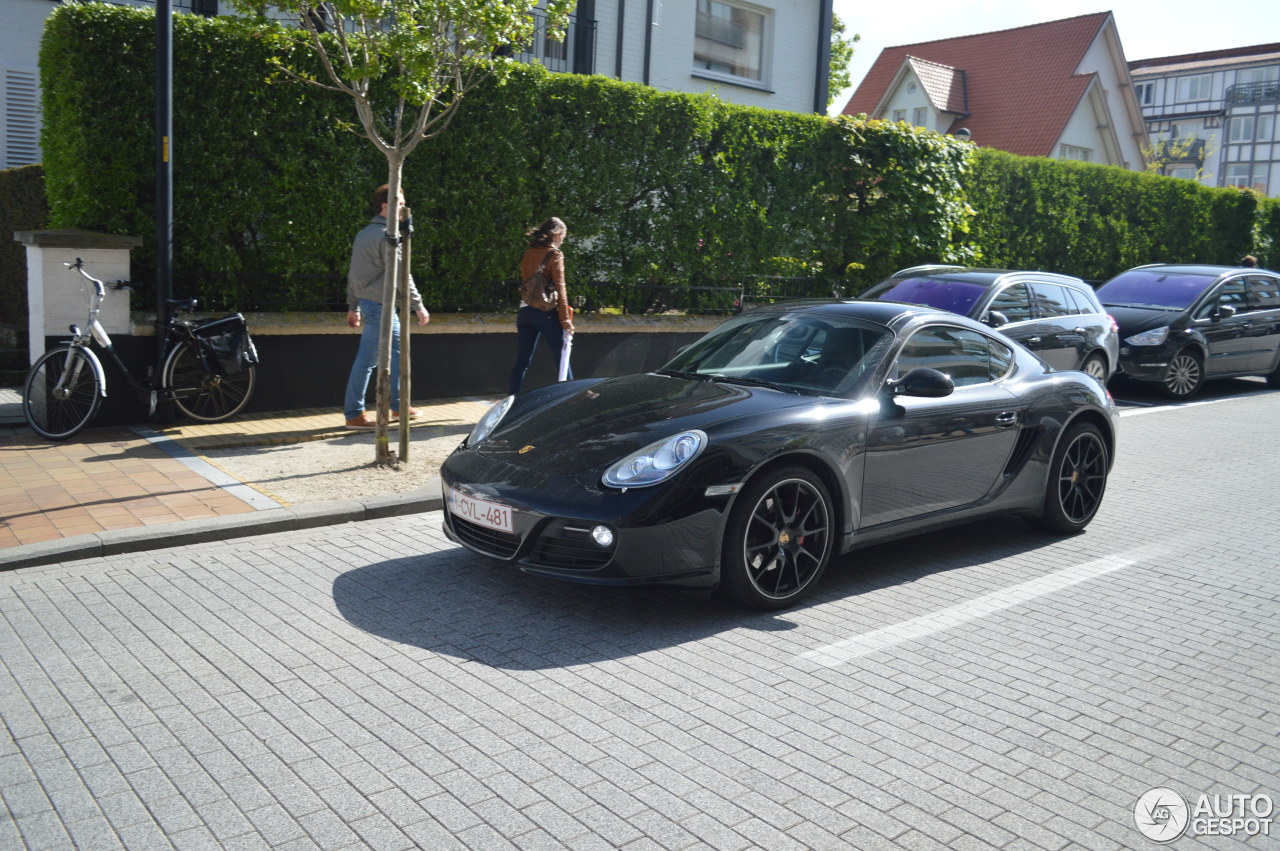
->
xmin=1098 ymin=265 xmax=1280 ymax=399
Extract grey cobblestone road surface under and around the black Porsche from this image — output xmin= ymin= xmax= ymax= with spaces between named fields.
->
xmin=0 ymin=393 xmax=1280 ymax=851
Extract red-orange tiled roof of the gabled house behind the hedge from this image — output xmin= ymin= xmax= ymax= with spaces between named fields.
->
xmin=844 ymin=12 xmax=1111 ymax=156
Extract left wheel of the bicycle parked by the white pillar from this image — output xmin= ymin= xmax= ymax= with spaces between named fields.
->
xmin=22 ymin=348 xmax=102 ymax=440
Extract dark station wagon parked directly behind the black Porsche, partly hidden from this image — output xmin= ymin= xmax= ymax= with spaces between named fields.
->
xmin=859 ymin=266 xmax=1120 ymax=381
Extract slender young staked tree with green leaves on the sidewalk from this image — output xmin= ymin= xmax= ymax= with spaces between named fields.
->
xmin=233 ymin=0 xmax=573 ymax=466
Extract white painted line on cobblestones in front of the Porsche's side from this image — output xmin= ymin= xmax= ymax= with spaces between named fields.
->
xmin=799 ymin=555 xmax=1138 ymax=668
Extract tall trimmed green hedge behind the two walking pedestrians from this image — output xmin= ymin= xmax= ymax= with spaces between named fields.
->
xmin=41 ymin=5 xmax=968 ymax=306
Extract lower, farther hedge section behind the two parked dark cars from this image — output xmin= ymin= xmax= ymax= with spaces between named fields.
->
xmin=964 ymin=148 xmax=1260 ymax=279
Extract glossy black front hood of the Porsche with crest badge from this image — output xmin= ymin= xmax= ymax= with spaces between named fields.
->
xmin=476 ymin=372 xmax=814 ymax=475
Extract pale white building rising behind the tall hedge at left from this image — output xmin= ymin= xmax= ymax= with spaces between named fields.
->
xmin=0 ymin=0 xmax=832 ymax=168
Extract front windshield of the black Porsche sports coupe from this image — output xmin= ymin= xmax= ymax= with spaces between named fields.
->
xmin=662 ymin=312 xmax=892 ymax=395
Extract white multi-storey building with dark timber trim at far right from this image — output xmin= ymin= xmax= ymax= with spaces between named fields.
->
xmin=1129 ymin=44 xmax=1280 ymax=196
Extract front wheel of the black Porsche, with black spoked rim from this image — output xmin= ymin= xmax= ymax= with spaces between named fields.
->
xmin=721 ymin=467 xmax=835 ymax=609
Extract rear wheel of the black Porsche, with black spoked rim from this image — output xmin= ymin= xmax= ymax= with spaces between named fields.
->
xmin=1039 ymin=422 xmax=1107 ymax=535
